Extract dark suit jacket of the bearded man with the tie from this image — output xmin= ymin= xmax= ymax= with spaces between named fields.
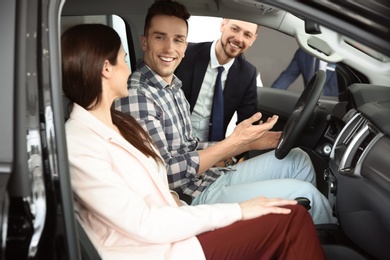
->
xmin=175 ymin=42 xmax=257 ymax=133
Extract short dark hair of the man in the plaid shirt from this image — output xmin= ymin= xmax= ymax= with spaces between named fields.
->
xmin=144 ymin=0 xmax=190 ymax=36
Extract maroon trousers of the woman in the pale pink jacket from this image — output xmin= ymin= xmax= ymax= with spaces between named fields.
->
xmin=197 ymin=205 xmax=326 ymax=260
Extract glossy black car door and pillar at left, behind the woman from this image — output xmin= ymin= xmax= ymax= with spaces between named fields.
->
xmin=0 ymin=0 xmax=81 ymax=259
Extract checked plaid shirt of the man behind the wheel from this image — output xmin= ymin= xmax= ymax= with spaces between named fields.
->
xmin=115 ymin=61 xmax=221 ymax=197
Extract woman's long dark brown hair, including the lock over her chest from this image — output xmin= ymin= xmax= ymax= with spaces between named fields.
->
xmin=61 ymin=24 xmax=163 ymax=163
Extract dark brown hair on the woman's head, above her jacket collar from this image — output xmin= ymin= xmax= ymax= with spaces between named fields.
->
xmin=61 ymin=24 xmax=121 ymax=109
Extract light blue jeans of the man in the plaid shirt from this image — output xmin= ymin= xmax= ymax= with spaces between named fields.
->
xmin=192 ymin=148 xmax=337 ymax=224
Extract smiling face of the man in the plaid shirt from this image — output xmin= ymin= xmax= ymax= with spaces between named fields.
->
xmin=141 ymin=15 xmax=188 ymax=83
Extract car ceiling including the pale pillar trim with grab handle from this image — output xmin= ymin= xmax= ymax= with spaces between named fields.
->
xmin=62 ymin=0 xmax=390 ymax=85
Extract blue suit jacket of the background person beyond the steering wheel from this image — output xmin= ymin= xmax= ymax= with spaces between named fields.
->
xmin=271 ymin=48 xmax=339 ymax=96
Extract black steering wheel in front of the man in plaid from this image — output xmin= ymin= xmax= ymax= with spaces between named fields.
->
xmin=275 ymin=70 xmax=326 ymax=159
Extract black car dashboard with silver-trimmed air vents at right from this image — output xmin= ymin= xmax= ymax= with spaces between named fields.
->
xmin=324 ymin=84 xmax=390 ymax=259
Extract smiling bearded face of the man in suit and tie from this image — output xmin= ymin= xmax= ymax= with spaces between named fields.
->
xmin=217 ymin=19 xmax=258 ymax=64
